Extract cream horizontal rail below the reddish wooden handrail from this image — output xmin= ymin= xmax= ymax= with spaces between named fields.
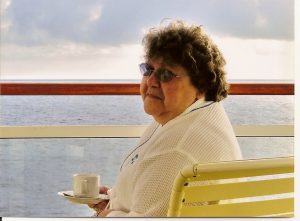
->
xmin=0 ymin=125 xmax=294 ymax=138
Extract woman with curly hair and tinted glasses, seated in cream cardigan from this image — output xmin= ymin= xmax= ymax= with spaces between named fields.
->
xmin=90 ymin=21 xmax=241 ymax=217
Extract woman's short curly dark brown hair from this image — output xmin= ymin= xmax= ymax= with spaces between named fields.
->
xmin=143 ymin=21 xmax=229 ymax=101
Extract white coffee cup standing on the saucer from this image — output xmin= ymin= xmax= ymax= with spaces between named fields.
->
xmin=73 ymin=174 xmax=100 ymax=198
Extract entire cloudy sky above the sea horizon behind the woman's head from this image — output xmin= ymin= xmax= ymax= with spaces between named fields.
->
xmin=0 ymin=0 xmax=294 ymax=80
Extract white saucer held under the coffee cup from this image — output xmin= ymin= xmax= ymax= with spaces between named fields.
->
xmin=57 ymin=190 xmax=109 ymax=204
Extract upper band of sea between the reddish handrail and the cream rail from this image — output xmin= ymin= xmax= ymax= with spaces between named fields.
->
xmin=0 ymin=95 xmax=294 ymax=125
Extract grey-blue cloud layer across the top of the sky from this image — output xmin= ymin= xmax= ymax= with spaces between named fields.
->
xmin=1 ymin=0 xmax=294 ymax=45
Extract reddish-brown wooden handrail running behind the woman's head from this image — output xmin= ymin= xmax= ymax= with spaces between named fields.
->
xmin=0 ymin=82 xmax=294 ymax=95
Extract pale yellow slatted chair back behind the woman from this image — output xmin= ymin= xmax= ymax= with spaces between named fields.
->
xmin=167 ymin=157 xmax=294 ymax=217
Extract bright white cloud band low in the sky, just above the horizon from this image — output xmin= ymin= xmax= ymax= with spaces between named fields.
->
xmin=1 ymin=36 xmax=294 ymax=80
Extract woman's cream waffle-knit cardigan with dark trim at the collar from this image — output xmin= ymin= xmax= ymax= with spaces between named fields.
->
xmin=108 ymin=101 xmax=242 ymax=217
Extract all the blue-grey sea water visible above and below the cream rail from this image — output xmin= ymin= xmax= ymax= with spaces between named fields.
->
xmin=0 ymin=96 xmax=294 ymax=217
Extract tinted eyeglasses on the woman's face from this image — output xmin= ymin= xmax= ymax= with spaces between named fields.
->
xmin=139 ymin=63 xmax=180 ymax=82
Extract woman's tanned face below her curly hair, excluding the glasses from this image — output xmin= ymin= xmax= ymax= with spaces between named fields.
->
xmin=140 ymin=59 xmax=202 ymax=125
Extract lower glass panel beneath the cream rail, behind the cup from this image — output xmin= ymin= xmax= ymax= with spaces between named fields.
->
xmin=0 ymin=137 xmax=294 ymax=217
